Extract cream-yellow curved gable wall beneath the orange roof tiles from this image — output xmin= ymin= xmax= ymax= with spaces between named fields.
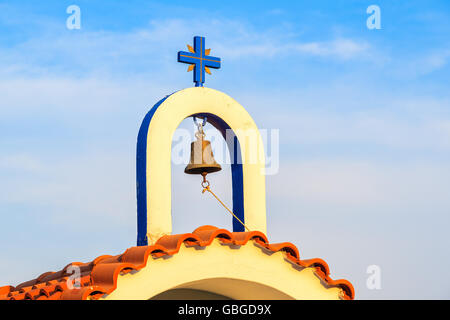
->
xmin=105 ymin=239 xmax=342 ymax=300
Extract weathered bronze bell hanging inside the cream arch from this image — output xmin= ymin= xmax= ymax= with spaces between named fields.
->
xmin=184 ymin=136 xmax=222 ymax=175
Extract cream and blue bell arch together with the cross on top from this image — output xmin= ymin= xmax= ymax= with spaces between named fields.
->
xmin=136 ymin=37 xmax=266 ymax=246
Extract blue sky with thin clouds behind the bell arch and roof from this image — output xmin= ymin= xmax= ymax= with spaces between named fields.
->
xmin=0 ymin=1 xmax=450 ymax=299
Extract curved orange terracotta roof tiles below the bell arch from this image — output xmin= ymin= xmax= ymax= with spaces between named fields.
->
xmin=0 ymin=226 xmax=355 ymax=300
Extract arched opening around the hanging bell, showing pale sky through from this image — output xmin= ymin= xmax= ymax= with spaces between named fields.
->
xmin=171 ymin=116 xmax=233 ymax=234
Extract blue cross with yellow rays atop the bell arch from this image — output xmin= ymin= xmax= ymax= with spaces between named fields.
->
xmin=178 ymin=36 xmax=220 ymax=87
